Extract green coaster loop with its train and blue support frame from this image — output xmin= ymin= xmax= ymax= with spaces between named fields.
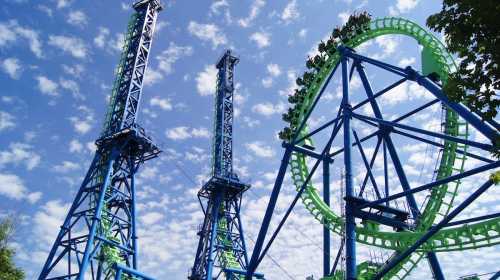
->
xmin=246 ymin=14 xmax=500 ymax=280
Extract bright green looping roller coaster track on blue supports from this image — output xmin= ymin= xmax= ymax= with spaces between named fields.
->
xmin=290 ymin=17 xmax=500 ymax=279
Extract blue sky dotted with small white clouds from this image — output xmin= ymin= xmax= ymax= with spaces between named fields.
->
xmin=0 ymin=0 xmax=500 ymax=279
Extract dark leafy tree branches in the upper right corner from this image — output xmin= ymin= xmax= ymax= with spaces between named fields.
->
xmin=427 ymin=0 xmax=500 ymax=120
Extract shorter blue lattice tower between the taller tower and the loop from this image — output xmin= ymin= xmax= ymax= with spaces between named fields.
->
xmin=188 ymin=50 xmax=262 ymax=280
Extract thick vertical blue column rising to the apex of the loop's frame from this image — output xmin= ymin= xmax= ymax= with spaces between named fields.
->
xmin=341 ymin=55 xmax=357 ymax=280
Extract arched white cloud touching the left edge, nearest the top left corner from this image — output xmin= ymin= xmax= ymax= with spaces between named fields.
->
xmin=0 ymin=20 xmax=42 ymax=57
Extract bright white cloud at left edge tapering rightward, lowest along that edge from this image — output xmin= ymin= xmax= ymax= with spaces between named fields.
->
xmin=0 ymin=173 xmax=42 ymax=203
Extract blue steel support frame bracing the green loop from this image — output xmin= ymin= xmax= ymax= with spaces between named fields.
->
xmin=245 ymin=47 xmax=500 ymax=280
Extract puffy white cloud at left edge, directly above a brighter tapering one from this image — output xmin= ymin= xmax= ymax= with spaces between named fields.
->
xmin=0 ymin=143 xmax=40 ymax=170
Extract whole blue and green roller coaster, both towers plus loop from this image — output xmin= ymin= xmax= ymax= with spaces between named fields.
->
xmin=38 ymin=0 xmax=500 ymax=280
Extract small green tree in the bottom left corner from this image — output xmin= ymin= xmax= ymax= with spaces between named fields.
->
xmin=0 ymin=218 xmax=24 ymax=280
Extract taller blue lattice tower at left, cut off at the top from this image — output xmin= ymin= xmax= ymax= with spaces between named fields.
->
xmin=38 ymin=0 xmax=162 ymax=280
